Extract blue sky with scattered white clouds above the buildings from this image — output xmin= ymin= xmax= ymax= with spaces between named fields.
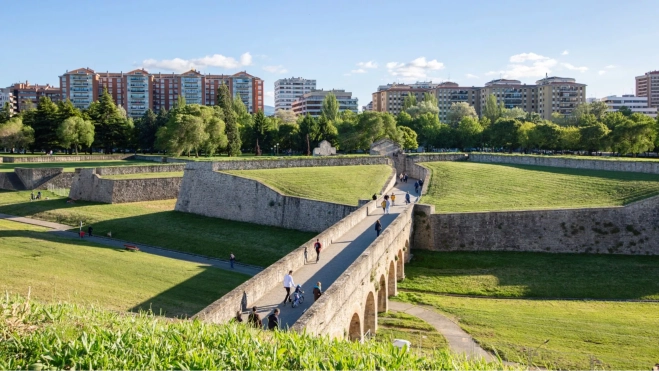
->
xmin=0 ymin=0 xmax=659 ymax=106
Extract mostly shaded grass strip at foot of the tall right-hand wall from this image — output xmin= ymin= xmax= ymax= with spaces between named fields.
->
xmin=399 ymin=251 xmax=659 ymax=300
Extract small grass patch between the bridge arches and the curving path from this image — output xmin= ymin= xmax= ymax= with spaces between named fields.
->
xmin=375 ymin=312 xmax=448 ymax=356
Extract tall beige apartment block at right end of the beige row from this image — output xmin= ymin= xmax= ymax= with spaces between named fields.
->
xmin=540 ymin=76 xmax=586 ymax=120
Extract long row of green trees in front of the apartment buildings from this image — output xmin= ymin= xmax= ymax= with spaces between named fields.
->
xmin=0 ymin=85 xmax=659 ymax=156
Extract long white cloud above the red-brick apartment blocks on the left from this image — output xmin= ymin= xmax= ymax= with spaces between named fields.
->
xmin=142 ymin=53 xmax=252 ymax=72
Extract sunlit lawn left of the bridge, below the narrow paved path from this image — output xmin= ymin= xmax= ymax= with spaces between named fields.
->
xmin=0 ymin=220 xmax=249 ymax=316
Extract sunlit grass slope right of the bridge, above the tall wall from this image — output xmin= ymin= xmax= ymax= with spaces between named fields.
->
xmin=422 ymin=162 xmax=659 ymax=213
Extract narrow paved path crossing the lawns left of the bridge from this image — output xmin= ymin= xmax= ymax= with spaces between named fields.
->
xmin=0 ymin=214 xmax=263 ymax=276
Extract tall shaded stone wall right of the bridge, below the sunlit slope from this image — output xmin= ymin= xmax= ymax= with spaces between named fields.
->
xmin=414 ymin=196 xmax=659 ymax=255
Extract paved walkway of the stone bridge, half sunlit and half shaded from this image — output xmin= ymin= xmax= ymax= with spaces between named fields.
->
xmin=254 ymin=178 xmax=417 ymax=328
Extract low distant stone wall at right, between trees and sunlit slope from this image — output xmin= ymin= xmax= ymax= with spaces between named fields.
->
xmin=469 ymin=154 xmax=659 ymax=174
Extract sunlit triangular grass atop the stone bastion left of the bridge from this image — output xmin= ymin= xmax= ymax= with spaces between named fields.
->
xmin=226 ymin=165 xmax=392 ymax=205
